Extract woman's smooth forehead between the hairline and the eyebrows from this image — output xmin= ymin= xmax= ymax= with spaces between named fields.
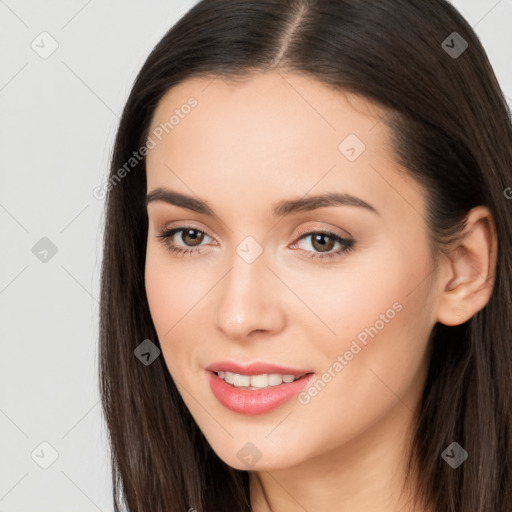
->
xmin=147 ymin=72 xmax=424 ymax=222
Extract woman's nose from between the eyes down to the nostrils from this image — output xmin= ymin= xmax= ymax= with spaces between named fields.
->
xmin=216 ymin=237 xmax=283 ymax=338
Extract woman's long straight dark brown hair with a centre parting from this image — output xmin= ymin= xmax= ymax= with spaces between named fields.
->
xmin=99 ymin=0 xmax=512 ymax=512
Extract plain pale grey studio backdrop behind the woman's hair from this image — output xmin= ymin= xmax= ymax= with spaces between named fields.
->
xmin=0 ymin=0 xmax=512 ymax=512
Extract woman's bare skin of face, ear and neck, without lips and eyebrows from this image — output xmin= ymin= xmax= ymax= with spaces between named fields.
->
xmin=145 ymin=72 xmax=496 ymax=512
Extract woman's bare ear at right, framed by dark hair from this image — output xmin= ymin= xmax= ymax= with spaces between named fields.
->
xmin=437 ymin=206 xmax=498 ymax=325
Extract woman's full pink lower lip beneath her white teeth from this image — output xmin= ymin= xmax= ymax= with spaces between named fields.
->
xmin=208 ymin=371 xmax=315 ymax=414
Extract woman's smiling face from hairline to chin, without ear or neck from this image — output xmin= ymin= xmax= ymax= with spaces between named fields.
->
xmin=145 ymin=72 xmax=439 ymax=470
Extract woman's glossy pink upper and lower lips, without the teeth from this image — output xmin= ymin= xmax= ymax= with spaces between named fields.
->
xmin=204 ymin=363 xmax=316 ymax=414
